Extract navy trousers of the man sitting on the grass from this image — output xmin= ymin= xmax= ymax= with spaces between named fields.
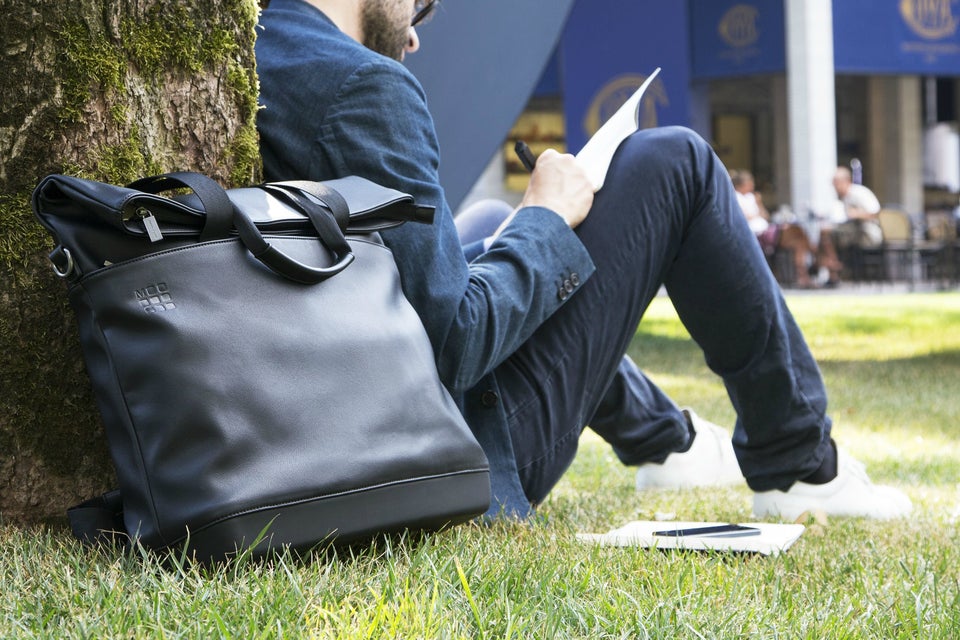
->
xmin=472 ymin=127 xmax=831 ymax=504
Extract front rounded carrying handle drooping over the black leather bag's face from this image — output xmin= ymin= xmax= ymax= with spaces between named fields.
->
xmin=233 ymin=192 xmax=354 ymax=284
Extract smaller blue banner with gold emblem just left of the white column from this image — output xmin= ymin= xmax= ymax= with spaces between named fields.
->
xmin=690 ymin=0 xmax=788 ymax=80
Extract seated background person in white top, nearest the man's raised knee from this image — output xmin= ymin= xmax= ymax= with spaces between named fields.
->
xmin=730 ymin=169 xmax=839 ymax=289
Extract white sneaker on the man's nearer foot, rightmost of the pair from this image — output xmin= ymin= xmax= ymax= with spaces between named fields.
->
xmin=753 ymin=449 xmax=913 ymax=522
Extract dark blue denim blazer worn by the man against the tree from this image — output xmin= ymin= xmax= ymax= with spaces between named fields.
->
xmin=256 ymin=0 xmax=594 ymax=517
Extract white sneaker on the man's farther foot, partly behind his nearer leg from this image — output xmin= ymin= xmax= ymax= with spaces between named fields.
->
xmin=637 ymin=409 xmax=743 ymax=491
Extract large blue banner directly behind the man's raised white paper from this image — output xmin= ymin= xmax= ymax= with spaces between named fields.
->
xmin=560 ymin=0 xmax=690 ymax=153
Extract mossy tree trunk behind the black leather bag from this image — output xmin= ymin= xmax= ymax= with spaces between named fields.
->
xmin=0 ymin=0 xmax=260 ymax=523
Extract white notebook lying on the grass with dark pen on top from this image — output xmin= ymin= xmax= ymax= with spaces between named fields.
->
xmin=577 ymin=520 xmax=804 ymax=555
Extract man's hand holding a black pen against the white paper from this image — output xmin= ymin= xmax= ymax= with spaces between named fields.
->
xmin=520 ymin=149 xmax=593 ymax=229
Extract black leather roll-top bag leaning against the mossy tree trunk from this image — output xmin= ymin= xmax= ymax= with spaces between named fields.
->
xmin=33 ymin=173 xmax=490 ymax=559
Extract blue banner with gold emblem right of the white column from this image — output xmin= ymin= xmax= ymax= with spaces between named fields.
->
xmin=833 ymin=0 xmax=960 ymax=76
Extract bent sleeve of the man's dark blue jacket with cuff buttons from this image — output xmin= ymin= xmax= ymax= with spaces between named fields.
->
xmin=311 ymin=59 xmax=594 ymax=392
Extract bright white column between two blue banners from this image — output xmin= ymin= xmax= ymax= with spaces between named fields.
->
xmin=785 ymin=0 xmax=837 ymax=215
